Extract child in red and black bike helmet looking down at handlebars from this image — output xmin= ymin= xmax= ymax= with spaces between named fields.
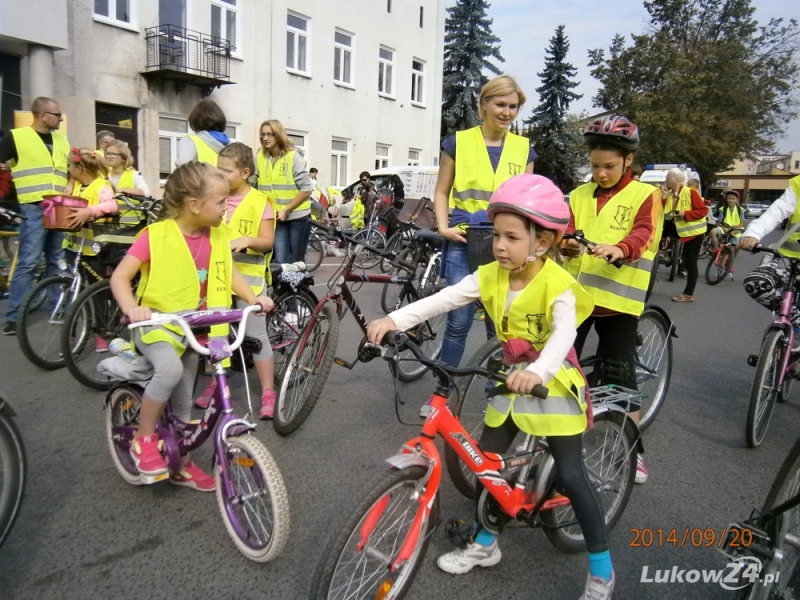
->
xmin=561 ymin=115 xmax=661 ymax=483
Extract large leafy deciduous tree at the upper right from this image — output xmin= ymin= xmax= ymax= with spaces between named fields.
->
xmin=589 ymin=0 xmax=800 ymax=180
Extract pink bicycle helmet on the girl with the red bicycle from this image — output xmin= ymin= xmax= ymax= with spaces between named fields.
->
xmin=487 ymin=173 xmax=569 ymax=243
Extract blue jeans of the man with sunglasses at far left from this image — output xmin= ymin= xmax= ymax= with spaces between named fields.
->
xmin=6 ymin=203 xmax=64 ymax=322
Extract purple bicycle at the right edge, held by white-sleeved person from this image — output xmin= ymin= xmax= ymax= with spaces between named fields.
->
xmin=745 ymin=245 xmax=800 ymax=448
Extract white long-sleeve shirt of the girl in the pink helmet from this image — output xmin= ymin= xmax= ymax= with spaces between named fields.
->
xmin=389 ymin=272 xmax=577 ymax=385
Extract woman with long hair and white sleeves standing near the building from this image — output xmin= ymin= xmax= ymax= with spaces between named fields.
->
xmin=256 ymin=119 xmax=314 ymax=263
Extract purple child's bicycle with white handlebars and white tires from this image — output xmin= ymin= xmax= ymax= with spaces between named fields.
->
xmin=106 ymin=306 xmax=289 ymax=562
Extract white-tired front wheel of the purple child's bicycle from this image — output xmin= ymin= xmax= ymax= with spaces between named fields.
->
xmin=215 ymin=434 xmax=290 ymax=562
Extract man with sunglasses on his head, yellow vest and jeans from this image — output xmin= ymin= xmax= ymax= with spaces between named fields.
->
xmin=0 ymin=96 xmax=70 ymax=335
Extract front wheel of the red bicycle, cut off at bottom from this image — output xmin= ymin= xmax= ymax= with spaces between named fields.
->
xmin=310 ymin=467 xmax=439 ymax=600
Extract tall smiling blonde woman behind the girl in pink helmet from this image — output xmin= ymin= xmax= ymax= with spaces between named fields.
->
xmin=428 ymin=75 xmax=536 ymax=417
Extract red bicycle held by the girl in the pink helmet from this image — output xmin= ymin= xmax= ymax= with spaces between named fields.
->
xmin=310 ymin=332 xmax=639 ymax=600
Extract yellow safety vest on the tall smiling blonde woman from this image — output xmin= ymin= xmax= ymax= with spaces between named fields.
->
xmin=452 ymin=126 xmax=531 ymax=213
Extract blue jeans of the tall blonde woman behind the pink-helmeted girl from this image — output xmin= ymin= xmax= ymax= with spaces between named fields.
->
xmin=442 ymin=242 xmax=495 ymax=386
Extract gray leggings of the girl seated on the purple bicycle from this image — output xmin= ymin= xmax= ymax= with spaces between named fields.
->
xmin=136 ymin=335 xmax=200 ymax=422
